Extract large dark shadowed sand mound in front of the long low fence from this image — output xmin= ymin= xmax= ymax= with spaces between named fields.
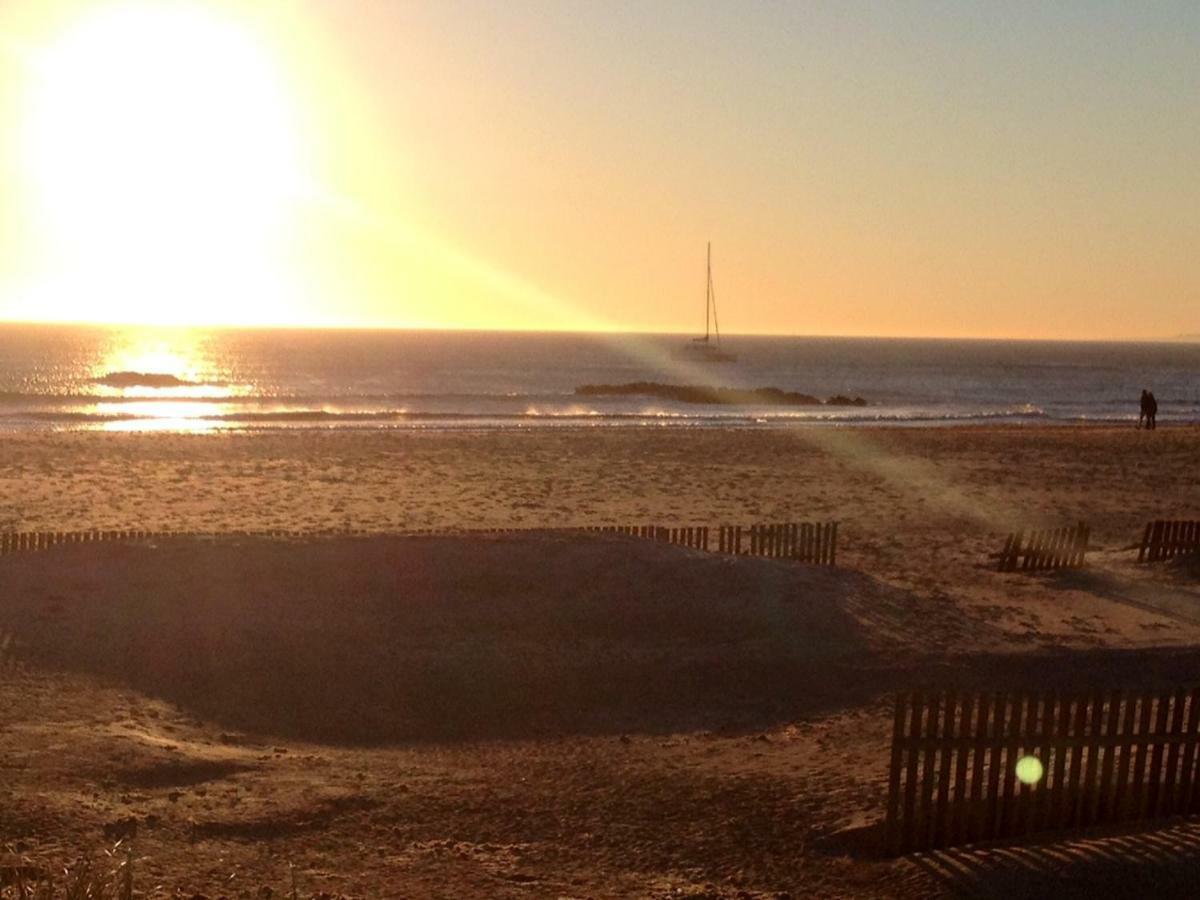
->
xmin=0 ymin=534 xmax=883 ymax=742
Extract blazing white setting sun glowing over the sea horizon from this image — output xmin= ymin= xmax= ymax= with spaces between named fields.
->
xmin=20 ymin=0 xmax=304 ymax=324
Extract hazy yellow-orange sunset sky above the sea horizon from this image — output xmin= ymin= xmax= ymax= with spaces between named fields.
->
xmin=0 ymin=0 xmax=1200 ymax=340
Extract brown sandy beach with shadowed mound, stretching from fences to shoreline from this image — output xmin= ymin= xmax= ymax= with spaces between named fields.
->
xmin=0 ymin=426 xmax=1200 ymax=898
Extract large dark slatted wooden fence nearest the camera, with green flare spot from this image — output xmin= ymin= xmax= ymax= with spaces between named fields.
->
xmin=887 ymin=688 xmax=1200 ymax=853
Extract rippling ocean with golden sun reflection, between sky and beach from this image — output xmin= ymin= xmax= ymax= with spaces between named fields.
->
xmin=0 ymin=325 xmax=1200 ymax=431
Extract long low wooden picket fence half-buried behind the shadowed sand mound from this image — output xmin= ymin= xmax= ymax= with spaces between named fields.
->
xmin=0 ymin=522 xmax=838 ymax=565
